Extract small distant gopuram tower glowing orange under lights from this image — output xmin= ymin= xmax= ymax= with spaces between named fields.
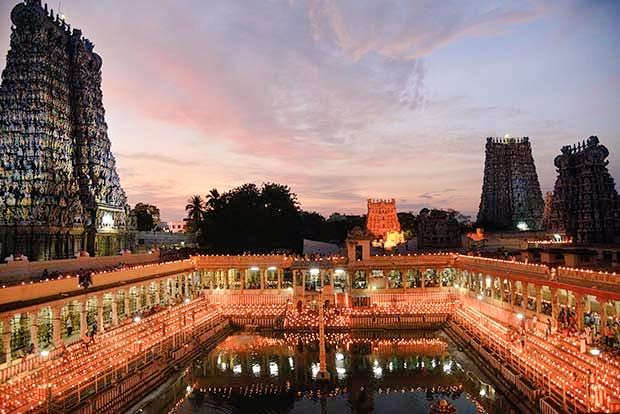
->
xmin=366 ymin=199 xmax=405 ymax=249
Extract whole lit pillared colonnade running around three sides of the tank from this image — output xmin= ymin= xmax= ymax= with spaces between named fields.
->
xmin=0 ymin=256 xmax=620 ymax=363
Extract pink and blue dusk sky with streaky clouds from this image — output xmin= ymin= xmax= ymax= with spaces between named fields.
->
xmin=0 ymin=0 xmax=620 ymax=220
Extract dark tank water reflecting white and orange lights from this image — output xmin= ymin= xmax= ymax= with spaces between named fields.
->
xmin=153 ymin=333 xmax=507 ymax=414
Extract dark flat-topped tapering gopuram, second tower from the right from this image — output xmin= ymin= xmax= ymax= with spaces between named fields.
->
xmin=478 ymin=137 xmax=544 ymax=230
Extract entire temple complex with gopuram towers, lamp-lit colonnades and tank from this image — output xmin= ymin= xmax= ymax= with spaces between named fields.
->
xmin=0 ymin=0 xmax=620 ymax=414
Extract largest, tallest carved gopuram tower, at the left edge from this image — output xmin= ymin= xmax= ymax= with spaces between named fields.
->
xmin=0 ymin=0 xmax=132 ymax=260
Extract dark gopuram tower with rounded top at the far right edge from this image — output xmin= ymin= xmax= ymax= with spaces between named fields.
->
xmin=550 ymin=136 xmax=620 ymax=244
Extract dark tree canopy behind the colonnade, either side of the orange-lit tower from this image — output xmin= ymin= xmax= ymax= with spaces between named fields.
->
xmin=185 ymin=183 xmax=467 ymax=254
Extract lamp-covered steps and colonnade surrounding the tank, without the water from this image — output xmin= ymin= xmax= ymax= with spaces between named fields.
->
xmin=0 ymin=244 xmax=620 ymax=414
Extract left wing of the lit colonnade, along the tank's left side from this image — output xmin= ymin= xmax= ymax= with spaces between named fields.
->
xmin=0 ymin=272 xmax=204 ymax=364
